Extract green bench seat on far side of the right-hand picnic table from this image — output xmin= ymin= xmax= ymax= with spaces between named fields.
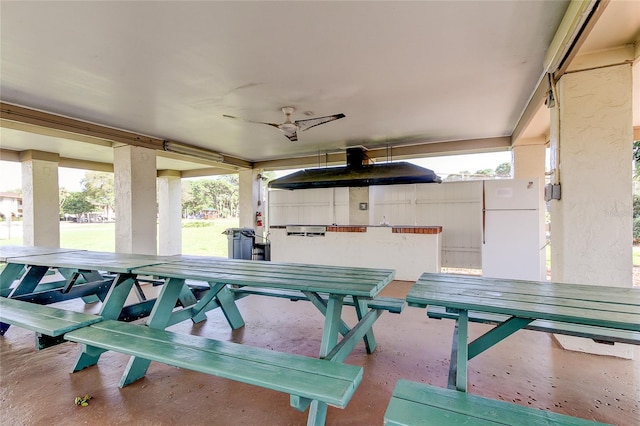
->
xmin=427 ymin=305 xmax=640 ymax=345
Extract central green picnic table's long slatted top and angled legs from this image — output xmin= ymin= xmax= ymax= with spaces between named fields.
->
xmin=76 ymin=256 xmax=395 ymax=424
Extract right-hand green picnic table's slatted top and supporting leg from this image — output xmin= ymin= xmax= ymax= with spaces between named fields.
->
xmin=406 ymin=273 xmax=640 ymax=391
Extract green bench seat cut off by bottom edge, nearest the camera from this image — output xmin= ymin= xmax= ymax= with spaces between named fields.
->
xmin=384 ymin=380 xmax=616 ymax=426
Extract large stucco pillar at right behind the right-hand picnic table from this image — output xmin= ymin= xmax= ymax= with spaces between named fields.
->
xmin=551 ymin=64 xmax=633 ymax=357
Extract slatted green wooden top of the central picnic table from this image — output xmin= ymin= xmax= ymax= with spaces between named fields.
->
xmin=132 ymin=256 xmax=395 ymax=297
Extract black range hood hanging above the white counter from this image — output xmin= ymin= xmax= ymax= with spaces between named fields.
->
xmin=269 ymin=148 xmax=442 ymax=189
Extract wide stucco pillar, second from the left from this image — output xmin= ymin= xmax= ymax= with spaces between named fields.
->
xmin=113 ymin=145 xmax=158 ymax=254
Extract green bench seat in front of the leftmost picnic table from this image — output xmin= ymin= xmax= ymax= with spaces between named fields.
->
xmin=0 ymin=297 xmax=102 ymax=349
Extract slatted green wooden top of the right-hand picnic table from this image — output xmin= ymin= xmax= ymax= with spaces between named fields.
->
xmin=407 ymin=273 xmax=640 ymax=331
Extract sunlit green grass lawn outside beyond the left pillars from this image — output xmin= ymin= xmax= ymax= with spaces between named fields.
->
xmin=0 ymin=218 xmax=238 ymax=257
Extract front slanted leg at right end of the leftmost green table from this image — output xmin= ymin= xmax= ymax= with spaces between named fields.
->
xmin=73 ymin=274 xmax=135 ymax=372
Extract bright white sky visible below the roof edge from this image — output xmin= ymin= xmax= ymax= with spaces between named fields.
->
xmin=0 ymin=151 xmax=511 ymax=192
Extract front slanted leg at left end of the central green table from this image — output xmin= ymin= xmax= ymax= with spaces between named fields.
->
xmin=119 ymin=278 xmax=186 ymax=388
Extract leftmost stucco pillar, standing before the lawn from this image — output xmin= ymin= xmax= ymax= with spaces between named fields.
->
xmin=20 ymin=151 xmax=60 ymax=247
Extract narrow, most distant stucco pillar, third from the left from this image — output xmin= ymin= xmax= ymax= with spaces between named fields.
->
xmin=158 ymin=170 xmax=182 ymax=256
